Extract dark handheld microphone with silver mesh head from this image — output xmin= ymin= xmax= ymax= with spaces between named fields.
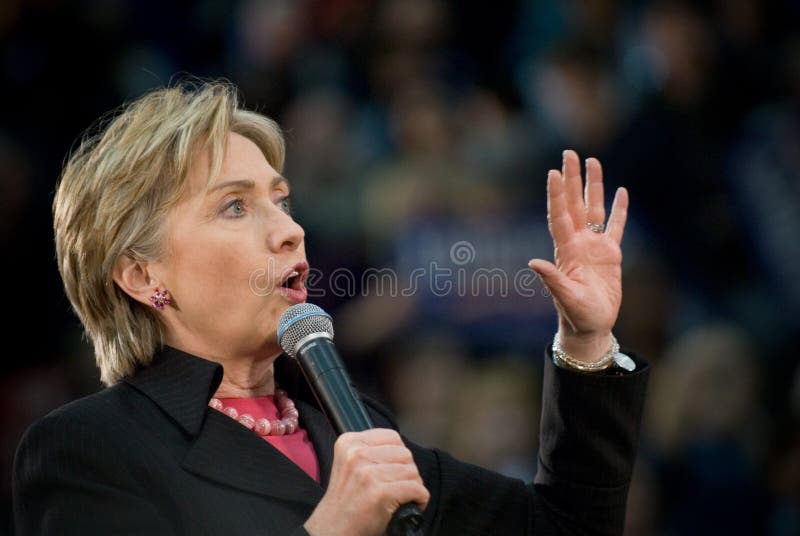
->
xmin=278 ymin=303 xmax=422 ymax=536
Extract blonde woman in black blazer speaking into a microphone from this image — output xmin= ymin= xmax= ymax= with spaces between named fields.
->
xmin=13 ymin=83 xmax=647 ymax=536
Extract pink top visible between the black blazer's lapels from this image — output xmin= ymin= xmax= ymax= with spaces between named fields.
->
xmin=220 ymin=395 xmax=319 ymax=482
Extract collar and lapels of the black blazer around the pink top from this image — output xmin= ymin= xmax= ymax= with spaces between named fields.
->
xmin=125 ymin=346 xmax=336 ymax=505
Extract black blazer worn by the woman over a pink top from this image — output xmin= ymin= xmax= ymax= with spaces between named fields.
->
xmin=13 ymin=348 xmax=647 ymax=536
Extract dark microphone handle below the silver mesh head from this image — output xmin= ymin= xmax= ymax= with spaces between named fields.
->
xmin=296 ymin=335 xmax=422 ymax=536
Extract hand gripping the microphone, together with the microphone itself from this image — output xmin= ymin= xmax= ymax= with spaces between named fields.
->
xmin=278 ymin=303 xmax=430 ymax=536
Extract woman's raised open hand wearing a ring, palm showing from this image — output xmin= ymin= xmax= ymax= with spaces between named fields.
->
xmin=528 ymin=150 xmax=628 ymax=361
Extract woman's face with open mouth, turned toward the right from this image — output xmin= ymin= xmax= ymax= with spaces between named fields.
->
xmin=151 ymin=134 xmax=308 ymax=358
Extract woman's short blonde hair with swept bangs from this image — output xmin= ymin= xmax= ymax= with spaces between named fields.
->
xmin=53 ymin=81 xmax=284 ymax=385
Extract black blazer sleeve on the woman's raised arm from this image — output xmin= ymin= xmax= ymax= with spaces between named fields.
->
xmin=362 ymin=352 xmax=649 ymax=536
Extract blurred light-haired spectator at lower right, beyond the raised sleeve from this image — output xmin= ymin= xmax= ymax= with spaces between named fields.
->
xmin=644 ymin=322 xmax=768 ymax=536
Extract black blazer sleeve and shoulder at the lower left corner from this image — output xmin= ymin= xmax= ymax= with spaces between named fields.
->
xmin=12 ymin=415 xmax=176 ymax=535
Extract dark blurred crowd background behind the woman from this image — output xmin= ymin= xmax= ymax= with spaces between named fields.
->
xmin=0 ymin=0 xmax=800 ymax=536
